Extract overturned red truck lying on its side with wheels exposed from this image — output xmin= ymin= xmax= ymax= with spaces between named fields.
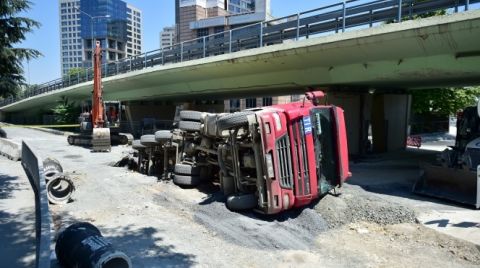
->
xmin=133 ymin=91 xmax=351 ymax=214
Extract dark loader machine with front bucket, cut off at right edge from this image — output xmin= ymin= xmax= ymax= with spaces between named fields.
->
xmin=413 ymin=102 xmax=480 ymax=209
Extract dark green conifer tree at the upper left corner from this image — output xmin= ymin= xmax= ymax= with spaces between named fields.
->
xmin=0 ymin=0 xmax=41 ymax=98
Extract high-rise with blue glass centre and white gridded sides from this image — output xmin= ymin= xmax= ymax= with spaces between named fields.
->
xmin=59 ymin=0 xmax=142 ymax=75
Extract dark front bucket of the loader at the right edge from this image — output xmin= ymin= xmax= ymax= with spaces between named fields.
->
xmin=413 ymin=164 xmax=480 ymax=209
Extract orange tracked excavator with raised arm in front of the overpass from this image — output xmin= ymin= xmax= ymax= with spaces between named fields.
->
xmin=68 ymin=41 xmax=133 ymax=152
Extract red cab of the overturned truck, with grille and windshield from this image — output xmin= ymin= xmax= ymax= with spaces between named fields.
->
xmin=221 ymin=91 xmax=351 ymax=214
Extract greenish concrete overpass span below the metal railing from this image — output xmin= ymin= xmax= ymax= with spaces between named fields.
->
xmin=1 ymin=11 xmax=480 ymax=112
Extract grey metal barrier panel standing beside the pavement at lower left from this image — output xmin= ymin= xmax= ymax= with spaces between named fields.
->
xmin=22 ymin=141 xmax=51 ymax=268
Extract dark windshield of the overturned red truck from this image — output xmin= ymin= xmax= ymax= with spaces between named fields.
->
xmin=310 ymin=107 xmax=340 ymax=188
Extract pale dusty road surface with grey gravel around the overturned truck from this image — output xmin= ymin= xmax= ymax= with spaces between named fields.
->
xmin=0 ymin=127 xmax=480 ymax=267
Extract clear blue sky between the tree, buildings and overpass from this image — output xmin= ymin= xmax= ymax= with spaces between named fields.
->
xmin=19 ymin=0 xmax=339 ymax=84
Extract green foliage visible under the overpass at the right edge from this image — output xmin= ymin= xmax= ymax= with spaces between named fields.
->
xmin=411 ymin=87 xmax=480 ymax=116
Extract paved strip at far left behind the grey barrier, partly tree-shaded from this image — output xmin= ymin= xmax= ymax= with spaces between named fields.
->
xmin=0 ymin=157 xmax=35 ymax=267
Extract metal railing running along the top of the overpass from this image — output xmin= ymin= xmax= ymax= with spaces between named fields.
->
xmin=0 ymin=0 xmax=480 ymax=107
